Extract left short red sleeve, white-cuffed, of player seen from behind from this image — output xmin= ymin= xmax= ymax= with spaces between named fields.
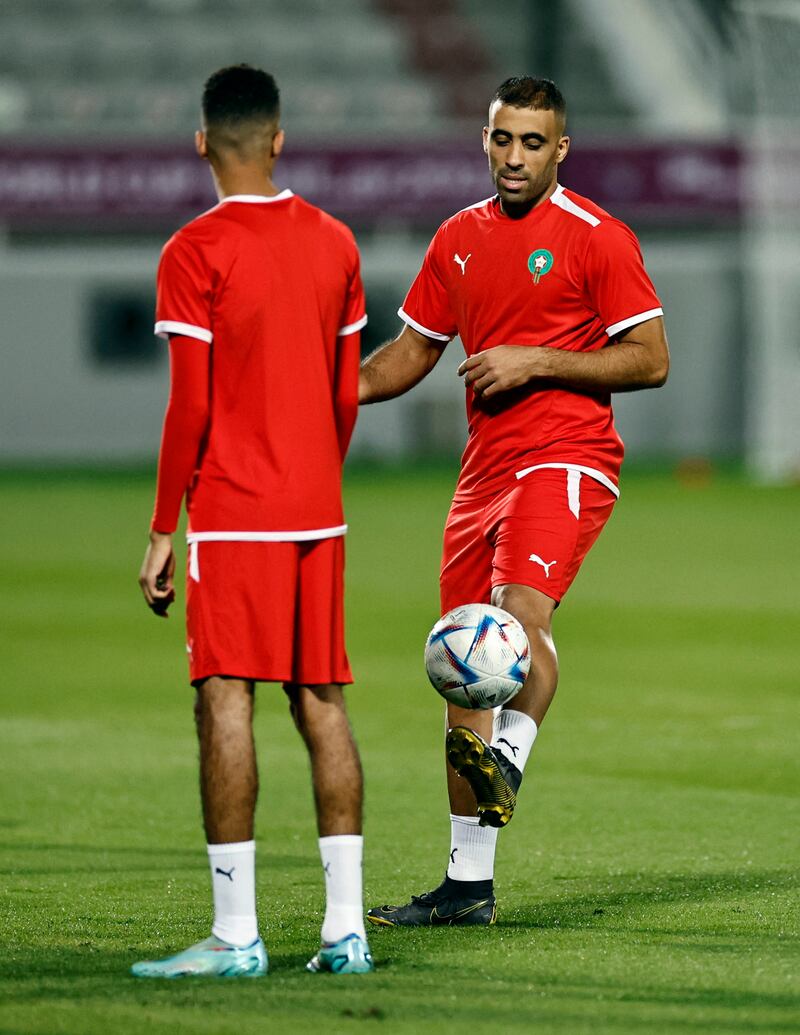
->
xmin=155 ymin=234 xmax=214 ymax=344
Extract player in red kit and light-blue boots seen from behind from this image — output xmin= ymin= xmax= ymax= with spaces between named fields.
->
xmin=134 ymin=65 xmax=373 ymax=977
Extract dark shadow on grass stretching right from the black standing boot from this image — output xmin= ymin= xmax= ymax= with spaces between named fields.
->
xmin=498 ymin=869 xmax=800 ymax=934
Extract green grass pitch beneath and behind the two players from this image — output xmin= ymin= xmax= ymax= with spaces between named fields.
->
xmin=0 ymin=469 xmax=800 ymax=1035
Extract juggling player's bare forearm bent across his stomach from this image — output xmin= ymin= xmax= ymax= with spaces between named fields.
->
xmin=458 ymin=317 xmax=670 ymax=397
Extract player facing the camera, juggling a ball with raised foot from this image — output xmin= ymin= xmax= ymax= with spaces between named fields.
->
xmin=359 ymin=77 xmax=669 ymax=925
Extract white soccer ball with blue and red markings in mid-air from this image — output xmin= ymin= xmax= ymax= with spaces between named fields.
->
xmin=425 ymin=603 xmax=531 ymax=708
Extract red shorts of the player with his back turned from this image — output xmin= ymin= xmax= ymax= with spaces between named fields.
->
xmin=186 ymin=536 xmax=353 ymax=685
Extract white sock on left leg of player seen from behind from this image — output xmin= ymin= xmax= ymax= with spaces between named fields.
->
xmin=208 ymin=841 xmax=259 ymax=947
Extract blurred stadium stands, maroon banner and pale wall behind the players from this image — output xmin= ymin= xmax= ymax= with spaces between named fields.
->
xmin=0 ymin=0 xmax=800 ymax=480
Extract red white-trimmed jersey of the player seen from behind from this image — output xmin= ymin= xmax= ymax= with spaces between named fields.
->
xmin=155 ymin=190 xmax=366 ymax=537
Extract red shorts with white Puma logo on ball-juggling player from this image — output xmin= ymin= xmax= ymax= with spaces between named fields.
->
xmin=439 ymin=468 xmax=617 ymax=614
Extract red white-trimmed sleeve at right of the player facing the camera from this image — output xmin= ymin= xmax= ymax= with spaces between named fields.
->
xmin=585 ymin=220 xmax=663 ymax=337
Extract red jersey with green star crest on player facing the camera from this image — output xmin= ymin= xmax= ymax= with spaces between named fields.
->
xmin=399 ymin=186 xmax=663 ymax=499
